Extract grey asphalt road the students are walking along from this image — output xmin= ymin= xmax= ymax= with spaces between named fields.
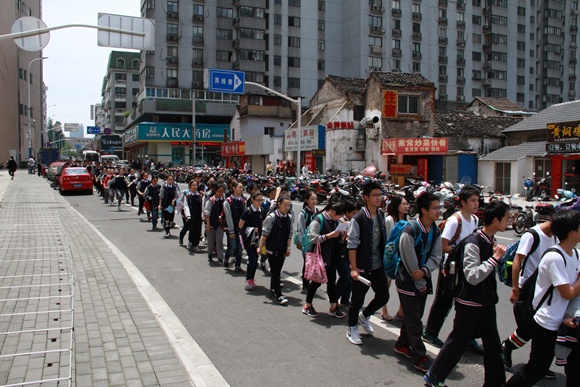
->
xmin=61 ymin=186 xmax=565 ymax=387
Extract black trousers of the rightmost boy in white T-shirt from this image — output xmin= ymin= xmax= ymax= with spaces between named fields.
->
xmin=506 ymin=321 xmax=560 ymax=387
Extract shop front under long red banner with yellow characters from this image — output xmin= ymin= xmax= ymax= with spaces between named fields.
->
xmin=381 ymin=138 xmax=448 ymax=187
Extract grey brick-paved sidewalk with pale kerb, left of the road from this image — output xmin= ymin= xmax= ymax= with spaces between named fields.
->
xmin=0 ymin=174 xmax=218 ymax=387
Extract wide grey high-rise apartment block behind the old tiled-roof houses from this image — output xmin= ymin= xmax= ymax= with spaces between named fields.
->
xmin=129 ymin=0 xmax=578 ymax=130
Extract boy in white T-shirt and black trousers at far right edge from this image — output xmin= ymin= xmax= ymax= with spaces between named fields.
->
xmin=505 ymin=210 xmax=580 ymax=387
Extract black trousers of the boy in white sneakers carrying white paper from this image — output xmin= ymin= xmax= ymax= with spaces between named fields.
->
xmin=348 ymin=267 xmax=389 ymax=327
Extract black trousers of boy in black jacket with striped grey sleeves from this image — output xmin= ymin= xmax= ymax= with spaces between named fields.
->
xmin=429 ymin=302 xmax=506 ymax=387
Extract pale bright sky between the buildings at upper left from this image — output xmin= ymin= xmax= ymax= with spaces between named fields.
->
xmin=42 ymin=0 xmax=140 ymax=137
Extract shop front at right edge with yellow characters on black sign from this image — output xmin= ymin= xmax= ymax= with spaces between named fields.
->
xmin=546 ymin=121 xmax=580 ymax=197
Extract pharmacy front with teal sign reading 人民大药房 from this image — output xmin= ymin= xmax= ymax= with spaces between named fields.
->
xmin=123 ymin=122 xmax=229 ymax=165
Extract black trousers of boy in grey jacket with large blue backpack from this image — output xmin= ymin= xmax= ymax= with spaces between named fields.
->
xmin=395 ymin=293 xmax=427 ymax=363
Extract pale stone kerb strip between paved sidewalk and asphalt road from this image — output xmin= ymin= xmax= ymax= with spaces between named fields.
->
xmin=65 ymin=197 xmax=229 ymax=387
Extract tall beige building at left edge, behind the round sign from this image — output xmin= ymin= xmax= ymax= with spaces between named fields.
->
xmin=0 ymin=0 xmax=45 ymax=161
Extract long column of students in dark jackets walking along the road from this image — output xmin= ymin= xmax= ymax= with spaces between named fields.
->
xmin=86 ymin=168 xmax=580 ymax=387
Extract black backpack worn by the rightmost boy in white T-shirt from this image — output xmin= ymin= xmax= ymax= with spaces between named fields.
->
xmin=514 ymin=247 xmax=578 ymax=327
